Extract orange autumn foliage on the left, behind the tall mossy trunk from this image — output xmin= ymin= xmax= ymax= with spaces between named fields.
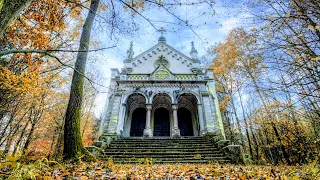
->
xmin=0 ymin=0 xmax=95 ymax=157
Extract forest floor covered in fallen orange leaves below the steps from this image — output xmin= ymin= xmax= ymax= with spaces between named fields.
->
xmin=0 ymin=159 xmax=320 ymax=180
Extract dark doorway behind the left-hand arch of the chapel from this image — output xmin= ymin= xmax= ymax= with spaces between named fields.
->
xmin=130 ymin=108 xmax=146 ymax=136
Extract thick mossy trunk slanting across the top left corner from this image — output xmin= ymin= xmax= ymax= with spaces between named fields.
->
xmin=0 ymin=0 xmax=32 ymax=40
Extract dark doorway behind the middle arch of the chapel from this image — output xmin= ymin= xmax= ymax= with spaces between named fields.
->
xmin=153 ymin=108 xmax=170 ymax=136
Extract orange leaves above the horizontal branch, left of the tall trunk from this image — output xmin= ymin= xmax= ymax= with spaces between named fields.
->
xmin=6 ymin=0 xmax=82 ymax=50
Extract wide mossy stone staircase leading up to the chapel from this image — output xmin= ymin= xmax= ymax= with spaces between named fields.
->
xmin=100 ymin=137 xmax=230 ymax=163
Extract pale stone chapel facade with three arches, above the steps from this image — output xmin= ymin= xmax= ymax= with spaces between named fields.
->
xmin=101 ymin=36 xmax=225 ymax=138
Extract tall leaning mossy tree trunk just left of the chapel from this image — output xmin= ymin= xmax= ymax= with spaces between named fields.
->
xmin=63 ymin=0 xmax=100 ymax=160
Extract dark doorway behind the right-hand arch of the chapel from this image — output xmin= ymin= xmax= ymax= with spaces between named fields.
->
xmin=178 ymin=108 xmax=193 ymax=136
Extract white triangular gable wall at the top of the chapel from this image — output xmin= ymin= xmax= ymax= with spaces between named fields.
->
xmin=125 ymin=43 xmax=194 ymax=74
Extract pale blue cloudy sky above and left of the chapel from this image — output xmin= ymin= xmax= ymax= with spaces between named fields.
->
xmin=88 ymin=0 xmax=255 ymax=117
